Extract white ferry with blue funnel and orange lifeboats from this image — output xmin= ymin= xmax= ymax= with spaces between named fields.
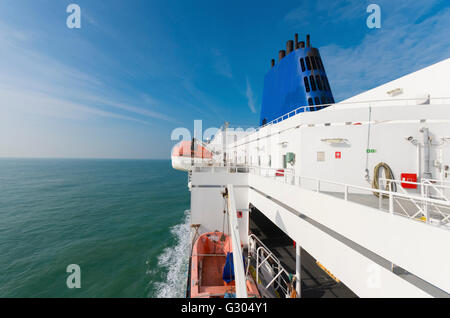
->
xmin=172 ymin=34 xmax=450 ymax=298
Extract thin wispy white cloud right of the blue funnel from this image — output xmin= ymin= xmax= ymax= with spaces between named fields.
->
xmin=321 ymin=2 xmax=450 ymax=100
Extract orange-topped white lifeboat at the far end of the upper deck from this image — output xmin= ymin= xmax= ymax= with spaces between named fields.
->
xmin=172 ymin=139 xmax=213 ymax=171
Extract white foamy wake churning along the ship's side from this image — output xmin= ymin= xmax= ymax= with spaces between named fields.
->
xmin=156 ymin=210 xmax=190 ymax=298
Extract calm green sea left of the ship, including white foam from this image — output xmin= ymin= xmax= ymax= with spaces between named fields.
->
xmin=0 ymin=159 xmax=189 ymax=297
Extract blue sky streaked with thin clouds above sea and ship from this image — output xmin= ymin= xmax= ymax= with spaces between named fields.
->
xmin=0 ymin=0 xmax=450 ymax=158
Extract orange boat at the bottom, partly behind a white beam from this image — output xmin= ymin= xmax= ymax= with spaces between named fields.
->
xmin=188 ymin=232 xmax=260 ymax=298
